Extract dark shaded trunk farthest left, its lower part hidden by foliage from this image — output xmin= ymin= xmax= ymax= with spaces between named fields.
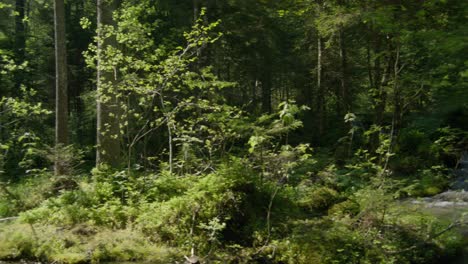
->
xmin=13 ymin=0 xmax=26 ymax=91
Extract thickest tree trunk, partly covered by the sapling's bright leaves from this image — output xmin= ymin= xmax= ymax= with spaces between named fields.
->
xmin=96 ymin=0 xmax=121 ymax=167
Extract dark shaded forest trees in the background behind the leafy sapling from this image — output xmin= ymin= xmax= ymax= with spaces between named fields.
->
xmin=1 ymin=0 xmax=466 ymax=173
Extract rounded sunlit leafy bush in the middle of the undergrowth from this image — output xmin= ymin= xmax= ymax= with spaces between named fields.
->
xmin=136 ymin=161 xmax=258 ymax=251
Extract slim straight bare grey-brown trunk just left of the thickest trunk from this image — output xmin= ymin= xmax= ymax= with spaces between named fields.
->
xmin=54 ymin=0 xmax=68 ymax=175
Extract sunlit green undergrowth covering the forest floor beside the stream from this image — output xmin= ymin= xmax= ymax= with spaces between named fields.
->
xmin=0 ymin=159 xmax=461 ymax=263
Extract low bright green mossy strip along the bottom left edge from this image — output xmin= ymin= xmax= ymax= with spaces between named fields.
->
xmin=0 ymin=223 xmax=179 ymax=264
